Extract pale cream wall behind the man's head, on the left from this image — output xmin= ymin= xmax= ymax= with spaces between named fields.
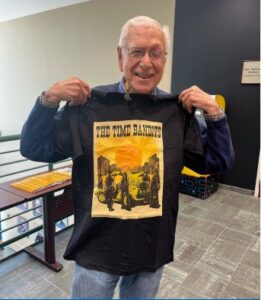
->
xmin=0 ymin=0 xmax=175 ymax=136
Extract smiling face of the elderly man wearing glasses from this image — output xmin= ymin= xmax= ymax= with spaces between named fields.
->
xmin=118 ymin=26 xmax=166 ymax=94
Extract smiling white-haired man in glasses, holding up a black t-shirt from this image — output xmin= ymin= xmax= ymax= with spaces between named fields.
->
xmin=21 ymin=16 xmax=234 ymax=298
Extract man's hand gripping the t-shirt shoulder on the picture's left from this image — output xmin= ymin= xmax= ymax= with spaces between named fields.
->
xmin=44 ymin=77 xmax=91 ymax=106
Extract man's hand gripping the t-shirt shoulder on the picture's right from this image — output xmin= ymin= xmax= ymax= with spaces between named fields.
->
xmin=179 ymin=85 xmax=220 ymax=115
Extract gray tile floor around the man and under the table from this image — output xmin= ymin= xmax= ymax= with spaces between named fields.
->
xmin=0 ymin=189 xmax=260 ymax=299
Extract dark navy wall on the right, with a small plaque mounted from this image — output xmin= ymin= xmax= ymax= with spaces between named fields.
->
xmin=172 ymin=0 xmax=260 ymax=190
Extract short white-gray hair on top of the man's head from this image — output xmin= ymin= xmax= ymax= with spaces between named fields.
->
xmin=119 ymin=16 xmax=170 ymax=52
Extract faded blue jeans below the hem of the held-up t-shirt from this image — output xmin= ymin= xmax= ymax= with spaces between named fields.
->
xmin=72 ymin=264 xmax=163 ymax=299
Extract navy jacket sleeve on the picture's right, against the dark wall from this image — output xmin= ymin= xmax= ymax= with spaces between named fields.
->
xmin=184 ymin=116 xmax=235 ymax=174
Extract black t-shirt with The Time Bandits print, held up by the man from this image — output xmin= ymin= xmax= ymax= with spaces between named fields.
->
xmin=56 ymin=91 xmax=202 ymax=275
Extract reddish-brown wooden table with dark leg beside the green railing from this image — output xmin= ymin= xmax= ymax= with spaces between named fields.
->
xmin=0 ymin=178 xmax=73 ymax=272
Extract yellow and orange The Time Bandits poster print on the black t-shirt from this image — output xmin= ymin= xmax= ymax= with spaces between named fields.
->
xmin=92 ymin=120 xmax=164 ymax=219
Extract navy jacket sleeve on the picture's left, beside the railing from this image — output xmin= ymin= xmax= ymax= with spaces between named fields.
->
xmin=20 ymin=98 xmax=72 ymax=162
